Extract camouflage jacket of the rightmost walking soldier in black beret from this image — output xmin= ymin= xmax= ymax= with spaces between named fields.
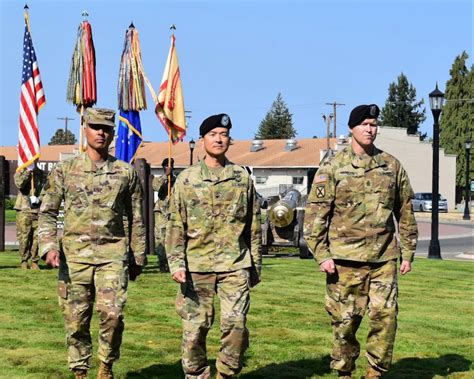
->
xmin=304 ymin=146 xmax=418 ymax=263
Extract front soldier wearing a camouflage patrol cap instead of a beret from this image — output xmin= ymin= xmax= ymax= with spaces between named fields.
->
xmin=39 ymin=108 xmax=146 ymax=378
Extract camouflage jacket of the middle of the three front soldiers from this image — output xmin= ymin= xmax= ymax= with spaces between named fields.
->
xmin=166 ymin=161 xmax=262 ymax=274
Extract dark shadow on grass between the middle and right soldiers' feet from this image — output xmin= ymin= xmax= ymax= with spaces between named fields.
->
xmin=240 ymin=355 xmax=331 ymax=379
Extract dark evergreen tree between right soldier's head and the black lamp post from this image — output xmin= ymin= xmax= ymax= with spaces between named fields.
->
xmin=380 ymin=72 xmax=426 ymax=134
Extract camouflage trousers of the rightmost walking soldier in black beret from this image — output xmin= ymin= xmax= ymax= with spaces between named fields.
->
xmin=326 ymin=260 xmax=398 ymax=371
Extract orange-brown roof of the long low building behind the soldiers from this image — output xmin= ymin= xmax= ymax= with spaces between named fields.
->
xmin=0 ymin=138 xmax=336 ymax=167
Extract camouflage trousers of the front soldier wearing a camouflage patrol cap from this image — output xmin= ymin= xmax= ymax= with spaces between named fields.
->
xmin=58 ymin=261 xmax=128 ymax=370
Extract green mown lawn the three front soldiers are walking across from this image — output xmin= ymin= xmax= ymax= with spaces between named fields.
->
xmin=0 ymin=251 xmax=474 ymax=379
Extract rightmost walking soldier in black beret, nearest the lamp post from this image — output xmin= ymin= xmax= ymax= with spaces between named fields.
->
xmin=304 ymin=104 xmax=418 ymax=378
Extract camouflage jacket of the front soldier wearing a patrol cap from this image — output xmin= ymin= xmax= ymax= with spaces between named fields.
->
xmin=38 ymin=153 xmax=145 ymax=265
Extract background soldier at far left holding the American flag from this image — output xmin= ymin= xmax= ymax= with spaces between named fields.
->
xmin=14 ymin=160 xmax=46 ymax=270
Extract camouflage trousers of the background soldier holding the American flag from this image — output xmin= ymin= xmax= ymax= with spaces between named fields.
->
xmin=16 ymin=211 xmax=39 ymax=262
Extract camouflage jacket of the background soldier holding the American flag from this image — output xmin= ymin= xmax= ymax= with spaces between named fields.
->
xmin=13 ymin=167 xmax=47 ymax=213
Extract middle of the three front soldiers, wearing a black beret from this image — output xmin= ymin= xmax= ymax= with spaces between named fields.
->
xmin=166 ymin=114 xmax=262 ymax=379
